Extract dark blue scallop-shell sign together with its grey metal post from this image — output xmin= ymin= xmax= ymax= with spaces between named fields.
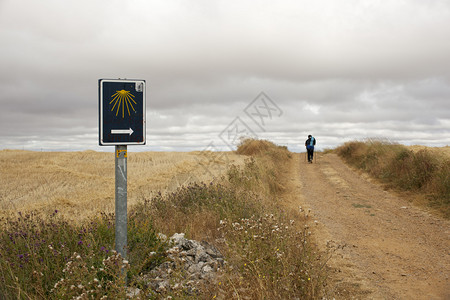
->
xmin=98 ymin=79 xmax=146 ymax=259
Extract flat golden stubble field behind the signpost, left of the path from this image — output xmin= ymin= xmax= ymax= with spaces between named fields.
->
xmin=0 ymin=150 xmax=244 ymax=220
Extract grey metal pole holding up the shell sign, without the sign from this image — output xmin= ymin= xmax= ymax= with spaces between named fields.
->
xmin=115 ymin=145 xmax=127 ymax=259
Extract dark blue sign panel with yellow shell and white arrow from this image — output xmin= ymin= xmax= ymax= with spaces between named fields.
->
xmin=99 ymin=79 xmax=145 ymax=145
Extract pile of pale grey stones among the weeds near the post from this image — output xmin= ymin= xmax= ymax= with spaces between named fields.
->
xmin=138 ymin=233 xmax=225 ymax=295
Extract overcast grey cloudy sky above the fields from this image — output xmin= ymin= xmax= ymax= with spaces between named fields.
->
xmin=0 ymin=0 xmax=450 ymax=151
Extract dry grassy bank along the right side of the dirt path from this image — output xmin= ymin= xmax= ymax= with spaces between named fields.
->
xmin=335 ymin=140 xmax=450 ymax=218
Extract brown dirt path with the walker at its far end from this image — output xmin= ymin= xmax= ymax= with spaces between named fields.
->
xmin=289 ymin=154 xmax=450 ymax=299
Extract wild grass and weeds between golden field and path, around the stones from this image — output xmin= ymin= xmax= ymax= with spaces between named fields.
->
xmin=0 ymin=140 xmax=326 ymax=299
